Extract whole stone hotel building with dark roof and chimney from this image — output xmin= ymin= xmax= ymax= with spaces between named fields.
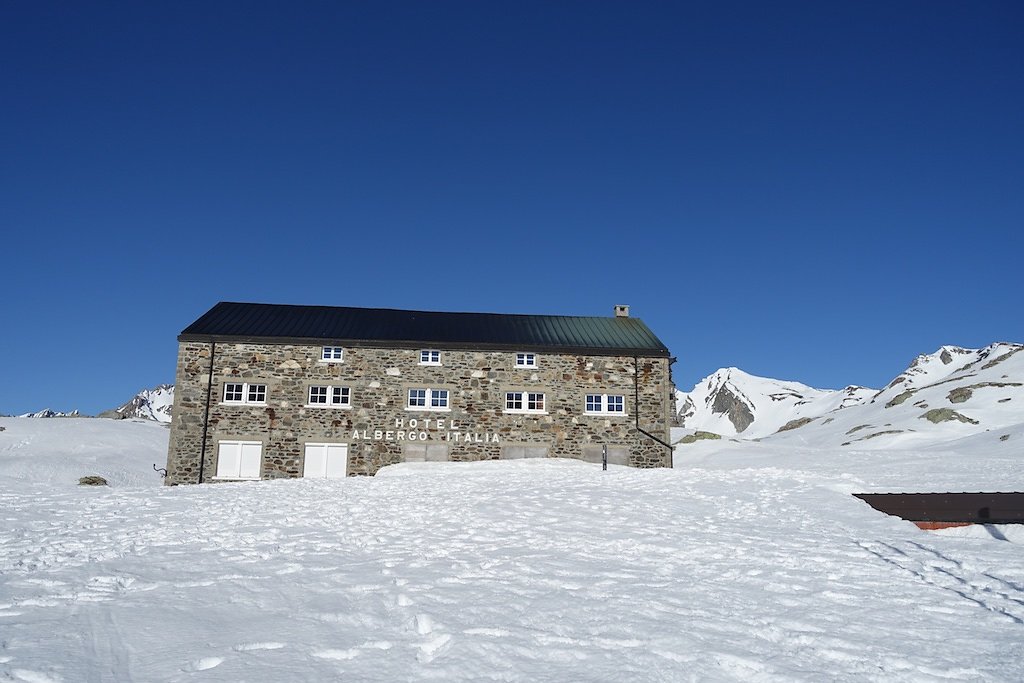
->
xmin=166 ymin=302 xmax=674 ymax=484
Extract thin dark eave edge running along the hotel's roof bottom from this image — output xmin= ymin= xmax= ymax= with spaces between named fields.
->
xmin=178 ymin=334 xmax=670 ymax=358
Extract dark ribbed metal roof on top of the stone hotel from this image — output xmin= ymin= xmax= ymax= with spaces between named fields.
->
xmin=178 ymin=301 xmax=669 ymax=356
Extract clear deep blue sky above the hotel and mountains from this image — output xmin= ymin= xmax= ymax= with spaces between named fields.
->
xmin=0 ymin=0 xmax=1024 ymax=414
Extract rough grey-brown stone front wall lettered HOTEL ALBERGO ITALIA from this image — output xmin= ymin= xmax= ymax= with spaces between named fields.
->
xmin=166 ymin=342 xmax=673 ymax=484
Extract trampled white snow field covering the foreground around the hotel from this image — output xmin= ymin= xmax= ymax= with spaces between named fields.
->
xmin=0 ymin=419 xmax=1024 ymax=682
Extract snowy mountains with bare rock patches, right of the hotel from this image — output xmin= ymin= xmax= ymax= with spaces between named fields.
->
xmin=677 ymin=343 xmax=1024 ymax=447
